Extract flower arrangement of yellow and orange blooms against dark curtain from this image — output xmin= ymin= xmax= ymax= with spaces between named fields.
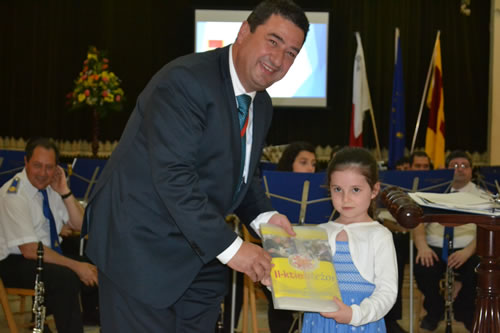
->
xmin=66 ymin=46 xmax=124 ymax=157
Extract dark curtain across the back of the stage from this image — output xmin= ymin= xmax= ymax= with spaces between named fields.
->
xmin=0 ymin=0 xmax=490 ymax=152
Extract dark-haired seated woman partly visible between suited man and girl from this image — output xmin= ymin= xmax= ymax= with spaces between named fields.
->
xmin=262 ymin=141 xmax=316 ymax=333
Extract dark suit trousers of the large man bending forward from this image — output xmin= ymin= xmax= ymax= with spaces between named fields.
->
xmin=99 ymin=260 xmax=227 ymax=333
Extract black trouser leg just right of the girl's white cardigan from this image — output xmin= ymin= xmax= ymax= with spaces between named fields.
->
xmin=384 ymin=232 xmax=410 ymax=321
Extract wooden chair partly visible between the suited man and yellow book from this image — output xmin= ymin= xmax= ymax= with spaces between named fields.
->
xmin=242 ymin=226 xmax=269 ymax=333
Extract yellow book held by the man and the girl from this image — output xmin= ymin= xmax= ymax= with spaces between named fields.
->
xmin=260 ymin=223 xmax=342 ymax=312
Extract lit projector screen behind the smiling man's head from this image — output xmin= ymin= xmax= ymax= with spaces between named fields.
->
xmin=195 ymin=9 xmax=328 ymax=107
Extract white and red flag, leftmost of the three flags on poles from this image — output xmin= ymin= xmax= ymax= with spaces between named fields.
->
xmin=349 ymin=32 xmax=372 ymax=147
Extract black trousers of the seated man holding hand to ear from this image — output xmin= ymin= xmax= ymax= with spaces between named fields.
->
xmin=0 ymin=255 xmax=83 ymax=333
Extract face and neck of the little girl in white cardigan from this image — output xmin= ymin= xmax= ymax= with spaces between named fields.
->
xmin=330 ymin=168 xmax=380 ymax=224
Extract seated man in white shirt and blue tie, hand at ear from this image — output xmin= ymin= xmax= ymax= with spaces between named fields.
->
xmin=0 ymin=137 xmax=97 ymax=333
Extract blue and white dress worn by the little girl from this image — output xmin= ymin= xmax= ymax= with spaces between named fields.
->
xmin=302 ymin=241 xmax=386 ymax=333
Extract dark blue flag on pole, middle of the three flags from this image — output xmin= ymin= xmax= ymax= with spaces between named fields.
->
xmin=388 ymin=29 xmax=406 ymax=169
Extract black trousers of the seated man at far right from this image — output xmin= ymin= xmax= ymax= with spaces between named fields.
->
xmin=415 ymin=247 xmax=479 ymax=327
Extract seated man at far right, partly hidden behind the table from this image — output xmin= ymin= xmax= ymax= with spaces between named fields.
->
xmin=414 ymin=150 xmax=484 ymax=331
